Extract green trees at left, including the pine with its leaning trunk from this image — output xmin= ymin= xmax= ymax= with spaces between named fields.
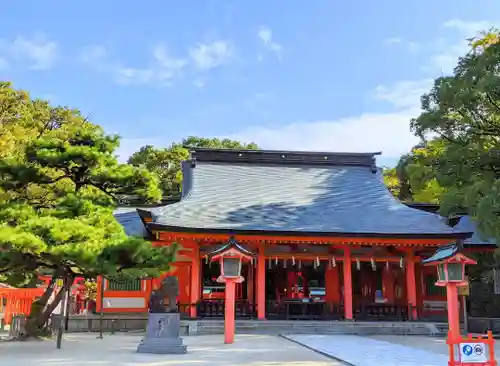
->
xmin=0 ymin=84 xmax=175 ymax=336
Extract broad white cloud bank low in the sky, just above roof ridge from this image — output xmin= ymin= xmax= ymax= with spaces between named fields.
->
xmin=229 ymin=80 xmax=430 ymax=158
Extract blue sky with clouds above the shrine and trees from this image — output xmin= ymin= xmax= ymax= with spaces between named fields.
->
xmin=0 ymin=0 xmax=500 ymax=164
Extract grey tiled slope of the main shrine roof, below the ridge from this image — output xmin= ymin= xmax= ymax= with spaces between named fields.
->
xmin=151 ymin=161 xmax=468 ymax=236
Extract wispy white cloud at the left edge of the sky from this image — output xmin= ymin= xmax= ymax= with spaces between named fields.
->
xmin=0 ymin=34 xmax=59 ymax=70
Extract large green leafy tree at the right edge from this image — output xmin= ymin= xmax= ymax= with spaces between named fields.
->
xmin=411 ymin=33 xmax=500 ymax=239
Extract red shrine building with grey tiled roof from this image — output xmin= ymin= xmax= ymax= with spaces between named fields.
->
xmin=98 ymin=148 xmax=494 ymax=320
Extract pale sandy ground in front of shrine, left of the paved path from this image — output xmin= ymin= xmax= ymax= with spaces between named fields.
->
xmin=0 ymin=334 xmax=341 ymax=366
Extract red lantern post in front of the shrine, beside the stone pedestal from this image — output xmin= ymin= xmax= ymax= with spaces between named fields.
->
xmin=209 ymin=237 xmax=253 ymax=344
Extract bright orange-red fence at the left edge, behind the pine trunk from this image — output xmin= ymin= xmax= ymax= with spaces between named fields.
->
xmin=0 ymin=288 xmax=45 ymax=324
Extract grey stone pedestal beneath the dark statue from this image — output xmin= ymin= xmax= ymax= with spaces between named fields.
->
xmin=137 ymin=313 xmax=187 ymax=354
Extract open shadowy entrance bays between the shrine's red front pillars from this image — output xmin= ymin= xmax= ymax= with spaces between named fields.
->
xmin=197 ymin=259 xmax=408 ymax=320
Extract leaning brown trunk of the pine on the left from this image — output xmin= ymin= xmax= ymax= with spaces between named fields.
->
xmin=21 ymin=275 xmax=74 ymax=338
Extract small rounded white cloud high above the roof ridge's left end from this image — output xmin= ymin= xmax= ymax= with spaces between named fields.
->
xmin=189 ymin=41 xmax=233 ymax=70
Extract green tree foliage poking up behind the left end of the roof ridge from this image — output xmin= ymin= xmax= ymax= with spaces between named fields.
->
xmin=128 ymin=136 xmax=259 ymax=196
